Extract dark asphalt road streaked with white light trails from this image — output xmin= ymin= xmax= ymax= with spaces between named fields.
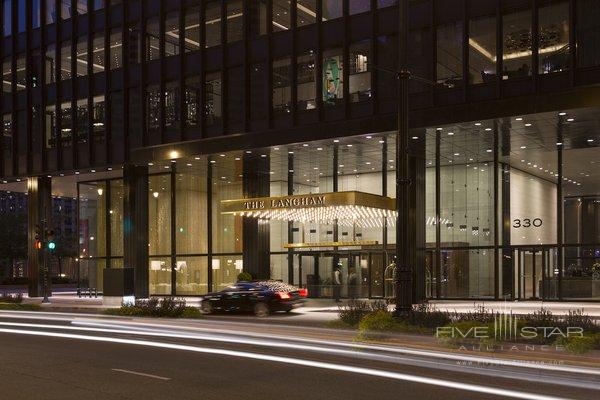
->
xmin=0 ymin=312 xmax=600 ymax=400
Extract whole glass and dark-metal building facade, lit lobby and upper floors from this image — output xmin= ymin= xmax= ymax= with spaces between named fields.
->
xmin=0 ymin=0 xmax=600 ymax=300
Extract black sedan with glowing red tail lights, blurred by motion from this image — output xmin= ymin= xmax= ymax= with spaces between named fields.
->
xmin=200 ymin=281 xmax=307 ymax=317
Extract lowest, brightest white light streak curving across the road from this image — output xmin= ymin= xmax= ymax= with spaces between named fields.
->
xmin=0 ymin=329 xmax=576 ymax=400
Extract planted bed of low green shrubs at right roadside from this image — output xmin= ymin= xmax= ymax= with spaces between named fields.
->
xmin=325 ymin=300 xmax=600 ymax=354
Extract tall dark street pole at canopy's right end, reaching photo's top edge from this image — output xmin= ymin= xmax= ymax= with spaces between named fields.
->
xmin=394 ymin=0 xmax=415 ymax=316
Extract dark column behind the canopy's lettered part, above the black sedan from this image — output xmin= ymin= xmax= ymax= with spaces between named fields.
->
xmin=242 ymin=153 xmax=271 ymax=279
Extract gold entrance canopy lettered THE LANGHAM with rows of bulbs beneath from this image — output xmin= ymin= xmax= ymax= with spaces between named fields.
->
xmin=221 ymin=191 xmax=396 ymax=227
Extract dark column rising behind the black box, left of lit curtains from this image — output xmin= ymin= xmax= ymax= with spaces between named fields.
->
xmin=123 ymin=164 xmax=150 ymax=298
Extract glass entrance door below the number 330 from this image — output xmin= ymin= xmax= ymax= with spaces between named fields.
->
xmin=514 ymin=247 xmax=557 ymax=300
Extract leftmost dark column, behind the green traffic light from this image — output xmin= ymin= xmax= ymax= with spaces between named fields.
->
xmin=27 ymin=177 xmax=52 ymax=297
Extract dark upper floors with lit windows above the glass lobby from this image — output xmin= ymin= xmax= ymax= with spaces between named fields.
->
xmin=0 ymin=0 xmax=600 ymax=180
